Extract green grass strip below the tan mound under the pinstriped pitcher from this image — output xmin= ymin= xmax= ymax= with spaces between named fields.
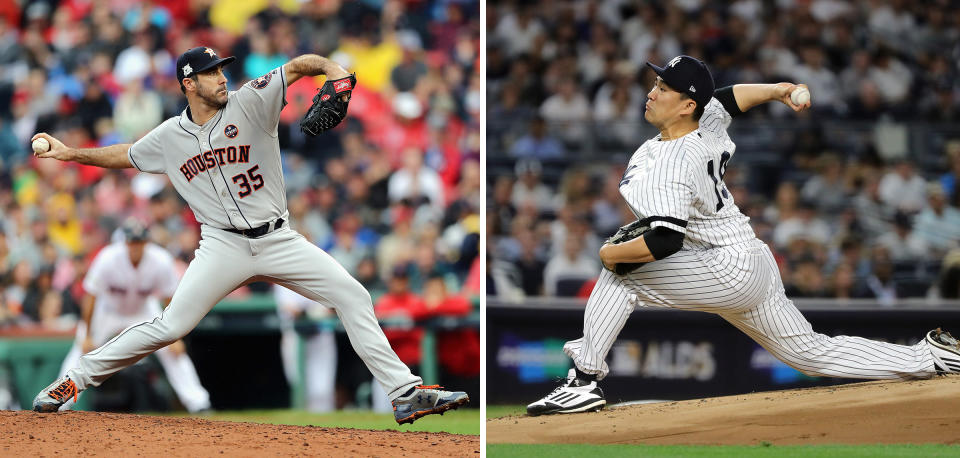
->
xmin=487 ymin=444 xmax=960 ymax=458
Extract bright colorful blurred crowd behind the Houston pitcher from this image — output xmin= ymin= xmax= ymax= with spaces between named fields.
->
xmin=0 ymin=0 xmax=482 ymax=362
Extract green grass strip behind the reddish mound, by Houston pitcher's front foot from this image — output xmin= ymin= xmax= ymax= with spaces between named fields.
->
xmin=160 ymin=409 xmax=482 ymax=436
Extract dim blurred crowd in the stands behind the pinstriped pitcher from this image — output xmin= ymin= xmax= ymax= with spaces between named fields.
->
xmin=487 ymin=0 xmax=960 ymax=304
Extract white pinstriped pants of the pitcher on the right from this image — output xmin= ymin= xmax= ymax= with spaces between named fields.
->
xmin=563 ymin=240 xmax=936 ymax=379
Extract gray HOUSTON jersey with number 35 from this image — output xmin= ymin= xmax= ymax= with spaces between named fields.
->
xmin=127 ymin=67 xmax=287 ymax=229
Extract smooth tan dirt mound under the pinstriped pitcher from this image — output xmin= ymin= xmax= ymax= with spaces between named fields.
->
xmin=487 ymin=377 xmax=960 ymax=445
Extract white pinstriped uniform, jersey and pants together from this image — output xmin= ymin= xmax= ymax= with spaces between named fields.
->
xmin=564 ymin=99 xmax=936 ymax=379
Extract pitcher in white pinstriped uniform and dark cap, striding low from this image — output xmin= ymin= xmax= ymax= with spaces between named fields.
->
xmin=527 ymin=56 xmax=960 ymax=415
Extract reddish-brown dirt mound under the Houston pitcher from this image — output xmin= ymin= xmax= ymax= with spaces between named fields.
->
xmin=0 ymin=411 xmax=480 ymax=458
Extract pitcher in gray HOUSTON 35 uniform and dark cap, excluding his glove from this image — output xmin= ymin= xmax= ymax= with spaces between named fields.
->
xmin=33 ymin=47 xmax=468 ymax=424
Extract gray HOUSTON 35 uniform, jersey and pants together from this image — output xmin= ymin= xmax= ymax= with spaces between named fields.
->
xmin=58 ymin=65 xmax=423 ymax=404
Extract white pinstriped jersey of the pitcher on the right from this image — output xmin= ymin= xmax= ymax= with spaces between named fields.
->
xmin=620 ymin=99 xmax=756 ymax=249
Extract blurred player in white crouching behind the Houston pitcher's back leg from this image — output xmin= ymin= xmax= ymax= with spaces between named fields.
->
xmin=60 ymin=220 xmax=210 ymax=413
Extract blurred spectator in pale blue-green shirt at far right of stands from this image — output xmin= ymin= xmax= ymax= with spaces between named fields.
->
xmin=914 ymin=181 xmax=960 ymax=258
